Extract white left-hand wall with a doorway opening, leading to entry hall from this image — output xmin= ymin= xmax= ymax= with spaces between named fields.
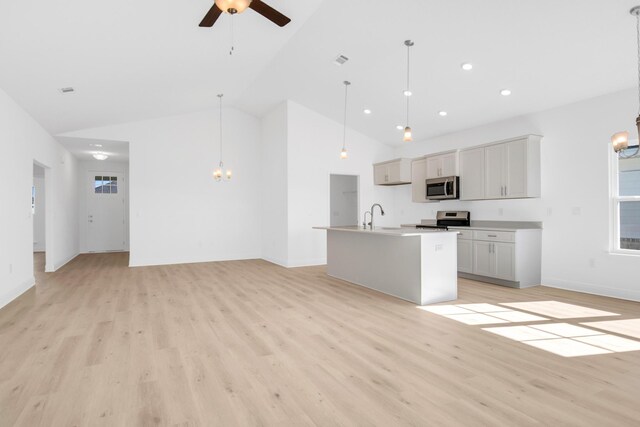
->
xmin=0 ymin=89 xmax=78 ymax=307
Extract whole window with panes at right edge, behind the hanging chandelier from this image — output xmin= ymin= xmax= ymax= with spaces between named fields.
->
xmin=612 ymin=145 xmax=640 ymax=254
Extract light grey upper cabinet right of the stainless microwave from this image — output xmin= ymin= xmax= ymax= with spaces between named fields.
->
xmin=460 ymin=135 xmax=541 ymax=200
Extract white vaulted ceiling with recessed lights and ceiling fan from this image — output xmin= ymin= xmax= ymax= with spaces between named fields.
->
xmin=0 ymin=0 xmax=640 ymax=144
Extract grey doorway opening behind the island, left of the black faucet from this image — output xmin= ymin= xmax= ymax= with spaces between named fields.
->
xmin=329 ymin=174 xmax=360 ymax=227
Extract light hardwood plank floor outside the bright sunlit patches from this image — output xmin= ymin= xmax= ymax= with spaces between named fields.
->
xmin=0 ymin=254 xmax=640 ymax=426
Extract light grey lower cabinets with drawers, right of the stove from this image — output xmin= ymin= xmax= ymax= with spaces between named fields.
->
xmin=458 ymin=229 xmax=542 ymax=288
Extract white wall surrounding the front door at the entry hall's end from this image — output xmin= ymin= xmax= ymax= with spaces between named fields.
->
xmin=78 ymin=160 xmax=129 ymax=253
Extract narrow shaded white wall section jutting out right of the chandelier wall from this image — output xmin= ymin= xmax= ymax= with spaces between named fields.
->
xmin=259 ymin=102 xmax=289 ymax=265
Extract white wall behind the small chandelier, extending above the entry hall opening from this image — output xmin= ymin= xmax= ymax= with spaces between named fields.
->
xmin=64 ymin=107 xmax=262 ymax=266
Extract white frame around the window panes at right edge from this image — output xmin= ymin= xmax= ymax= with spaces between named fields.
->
xmin=609 ymin=144 xmax=640 ymax=257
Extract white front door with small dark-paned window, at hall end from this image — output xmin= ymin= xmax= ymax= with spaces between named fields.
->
xmin=87 ymin=172 xmax=125 ymax=252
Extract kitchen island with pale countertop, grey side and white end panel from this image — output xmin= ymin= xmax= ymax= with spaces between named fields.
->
xmin=314 ymin=226 xmax=458 ymax=305
